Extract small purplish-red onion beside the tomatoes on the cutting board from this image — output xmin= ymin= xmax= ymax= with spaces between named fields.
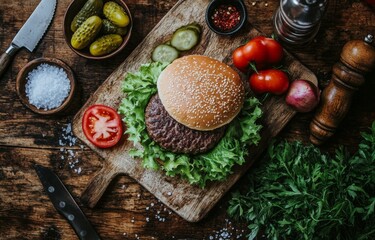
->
xmin=285 ymin=79 xmax=320 ymax=112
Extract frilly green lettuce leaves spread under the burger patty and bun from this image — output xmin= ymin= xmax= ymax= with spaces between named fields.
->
xmin=119 ymin=62 xmax=262 ymax=187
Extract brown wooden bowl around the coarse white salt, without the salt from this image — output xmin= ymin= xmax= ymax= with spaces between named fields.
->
xmin=16 ymin=58 xmax=76 ymax=115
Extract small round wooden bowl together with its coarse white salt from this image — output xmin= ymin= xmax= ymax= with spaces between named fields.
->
xmin=16 ymin=58 xmax=75 ymax=115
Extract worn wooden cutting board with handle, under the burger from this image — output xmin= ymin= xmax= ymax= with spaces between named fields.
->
xmin=73 ymin=0 xmax=317 ymax=222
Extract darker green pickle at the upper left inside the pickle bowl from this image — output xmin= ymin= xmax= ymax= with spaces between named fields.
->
xmin=70 ymin=0 xmax=103 ymax=32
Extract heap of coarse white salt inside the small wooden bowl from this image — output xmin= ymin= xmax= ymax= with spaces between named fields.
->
xmin=25 ymin=63 xmax=70 ymax=110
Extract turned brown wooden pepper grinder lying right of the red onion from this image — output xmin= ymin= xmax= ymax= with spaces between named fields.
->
xmin=310 ymin=34 xmax=375 ymax=145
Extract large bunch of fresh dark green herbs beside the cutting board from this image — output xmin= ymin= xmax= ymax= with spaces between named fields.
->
xmin=228 ymin=122 xmax=375 ymax=240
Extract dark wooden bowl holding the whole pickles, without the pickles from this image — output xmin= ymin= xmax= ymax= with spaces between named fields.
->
xmin=63 ymin=0 xmax=133 ymax=60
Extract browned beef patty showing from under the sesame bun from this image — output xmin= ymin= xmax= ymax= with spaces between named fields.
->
xmin=145 ymin=94 xmax=225 ymax=154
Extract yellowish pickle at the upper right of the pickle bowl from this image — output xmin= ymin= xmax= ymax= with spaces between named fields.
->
xmin=103 ymin=1 xmax=130 ymax=27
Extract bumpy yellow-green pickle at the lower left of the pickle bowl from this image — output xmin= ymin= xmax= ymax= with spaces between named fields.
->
xmin=70 ymin=16 xmax=103 ymax=50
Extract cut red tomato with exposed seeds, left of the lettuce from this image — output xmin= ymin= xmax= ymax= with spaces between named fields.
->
xmin=82 ymin=104 xmax=123 ymax=148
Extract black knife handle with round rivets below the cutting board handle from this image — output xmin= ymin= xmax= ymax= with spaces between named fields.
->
xmin=34 ymin=165 xmax=100 ymax=240
